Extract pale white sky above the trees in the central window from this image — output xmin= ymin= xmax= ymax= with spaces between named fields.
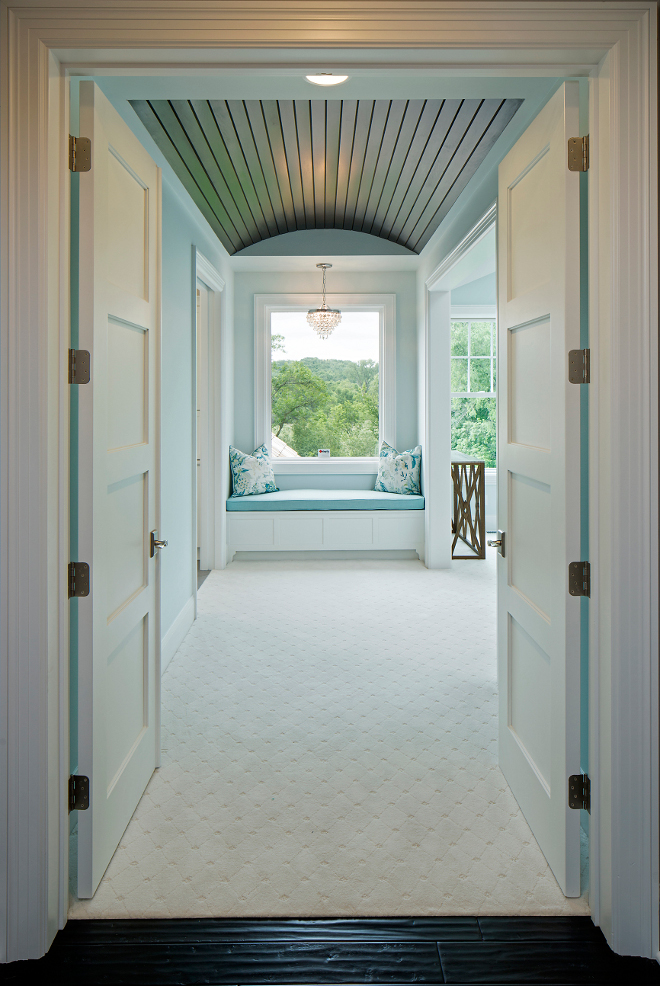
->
xmin=270 ymin=312 xmax=379 ymax=363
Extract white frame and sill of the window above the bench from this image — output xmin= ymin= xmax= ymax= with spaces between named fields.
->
xmin=254 ymin=292 xmax=396 ymax=474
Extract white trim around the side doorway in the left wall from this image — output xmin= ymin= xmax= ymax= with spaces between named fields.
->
xmin=193 ymin=249 xmax=228 ymax=576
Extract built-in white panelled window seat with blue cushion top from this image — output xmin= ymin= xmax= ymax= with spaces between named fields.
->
xmin=227 ymin=489 xmax=426 ymax=561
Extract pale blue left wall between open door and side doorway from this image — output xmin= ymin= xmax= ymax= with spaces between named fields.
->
xmin=160 ymin=182 xmax=233 ymax=636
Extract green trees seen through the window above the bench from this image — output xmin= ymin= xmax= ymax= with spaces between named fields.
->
xmin=272 ymin=356 xmax=378 ymax=456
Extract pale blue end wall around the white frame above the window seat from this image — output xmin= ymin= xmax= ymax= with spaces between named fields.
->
xmin=234 ymin=270 xmax=417 ymax=458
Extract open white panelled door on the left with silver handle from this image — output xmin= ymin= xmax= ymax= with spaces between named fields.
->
xmin=78 ymin=82 xmax=160 ymax=897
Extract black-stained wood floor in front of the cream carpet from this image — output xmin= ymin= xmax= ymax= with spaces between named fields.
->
xmin=0 ymin=917 xmax=660 ymax=986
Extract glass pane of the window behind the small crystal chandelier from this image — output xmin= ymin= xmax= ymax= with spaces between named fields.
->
xmin=270 ymin=311 xmax=380 ymax=458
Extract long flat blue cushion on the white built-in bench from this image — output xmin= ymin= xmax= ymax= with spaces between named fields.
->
xmin=227 ymin=490 xmax=424 ymax=511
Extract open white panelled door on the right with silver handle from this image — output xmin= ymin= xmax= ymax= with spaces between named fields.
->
xmin=498 ymin=82 xmax=580 ymax=897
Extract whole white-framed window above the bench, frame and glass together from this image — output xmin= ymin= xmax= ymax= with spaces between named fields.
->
xmin=254 ymin=293 xmax=396 ymax=466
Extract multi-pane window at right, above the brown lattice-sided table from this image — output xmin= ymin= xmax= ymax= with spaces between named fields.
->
xmin=451 ymin=318 xmax=497 ymax=467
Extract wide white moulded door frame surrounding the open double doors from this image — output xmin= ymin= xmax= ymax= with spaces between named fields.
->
xmin=0 ymin=0 xmax=659 ymax=960
